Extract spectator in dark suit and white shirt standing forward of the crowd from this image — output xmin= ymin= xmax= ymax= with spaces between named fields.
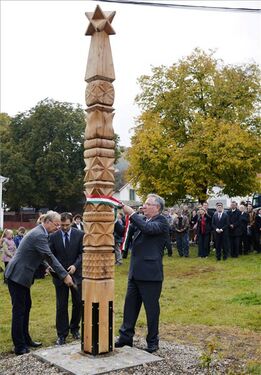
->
xmin=212 ymin=202 xmax=228 ymax=260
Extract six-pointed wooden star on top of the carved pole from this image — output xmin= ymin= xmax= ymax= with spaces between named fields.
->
xmin=85 ymin=5 xmax=116 ymax=35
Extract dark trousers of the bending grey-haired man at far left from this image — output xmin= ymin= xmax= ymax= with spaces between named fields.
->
xmin=8 ymin=280 xmax=32 ymax=352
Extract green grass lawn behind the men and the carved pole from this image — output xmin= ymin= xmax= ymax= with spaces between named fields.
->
xmin=0 ymin=248 xmax=261 ymax=352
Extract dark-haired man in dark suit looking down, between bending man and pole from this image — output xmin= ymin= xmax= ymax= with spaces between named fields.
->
xmin=50 ymin=212 xmax=84 ymax=345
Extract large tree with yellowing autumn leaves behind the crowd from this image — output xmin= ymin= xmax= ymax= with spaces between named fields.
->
xmin=128 ymin=49 xmax=260 ymax=204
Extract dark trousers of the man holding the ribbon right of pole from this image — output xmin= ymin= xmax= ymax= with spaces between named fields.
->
xmin=119 ymin=279 xmax=162 ymax=346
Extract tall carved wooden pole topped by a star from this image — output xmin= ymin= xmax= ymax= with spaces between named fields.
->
xmin=82 ymin=5 xmax=115 ymax=355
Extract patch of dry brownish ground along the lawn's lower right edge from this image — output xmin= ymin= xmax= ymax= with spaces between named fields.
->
xmin=137 ymin=324 xmax=261 ymax=374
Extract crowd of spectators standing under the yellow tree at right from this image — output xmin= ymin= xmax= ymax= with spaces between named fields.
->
xmin=159 ymin=201 xmax=261 ymax=260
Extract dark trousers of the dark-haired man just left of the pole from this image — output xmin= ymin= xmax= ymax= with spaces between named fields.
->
xmin=55 ymin=284 xmax=82 ymax=337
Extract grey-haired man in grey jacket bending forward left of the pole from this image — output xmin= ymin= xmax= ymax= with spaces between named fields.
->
xmin=5 ymin=211 xmax=73 ymax=355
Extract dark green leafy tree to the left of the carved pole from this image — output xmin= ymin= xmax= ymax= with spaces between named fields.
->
xmin=0 ymin=99 xmax=85 ymax=210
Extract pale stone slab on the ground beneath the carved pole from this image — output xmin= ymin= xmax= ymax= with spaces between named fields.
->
xmin=33 ymin=344 xmax=163 ymax=375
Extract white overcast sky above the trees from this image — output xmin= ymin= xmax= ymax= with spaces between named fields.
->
xmin=0 ymin=0 xmax=261 ymax=146
